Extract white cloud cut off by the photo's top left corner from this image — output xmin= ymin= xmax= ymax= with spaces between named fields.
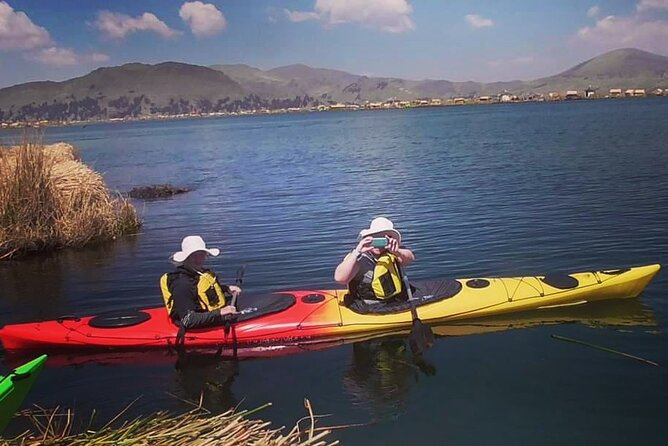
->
xmin=0 ymin=1 xmax=51 ymax=50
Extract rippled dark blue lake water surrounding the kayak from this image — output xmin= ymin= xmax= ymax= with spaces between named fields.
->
xmin=0 ymin=99 xmax=668 ymax=445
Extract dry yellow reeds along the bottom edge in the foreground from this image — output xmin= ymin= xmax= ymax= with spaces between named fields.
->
xmin=3 ymin=399 xmax=338 ymax=446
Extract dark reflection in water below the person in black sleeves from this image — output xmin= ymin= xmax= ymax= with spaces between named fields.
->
xmin=174 ymin=351 xmax=239 ymax=413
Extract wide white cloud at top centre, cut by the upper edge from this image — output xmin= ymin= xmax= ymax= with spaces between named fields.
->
xmin=285 ymin=0 xmax=415 ymax=33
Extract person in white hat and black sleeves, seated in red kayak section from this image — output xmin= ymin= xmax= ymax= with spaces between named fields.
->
xmin=160 ymin=235 xmax=241 ymax=330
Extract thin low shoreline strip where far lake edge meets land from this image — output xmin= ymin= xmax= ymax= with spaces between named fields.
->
xmin=0 ymin=95 xmax=666 ymax=130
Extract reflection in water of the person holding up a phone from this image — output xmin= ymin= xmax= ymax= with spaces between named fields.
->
xmin=343 ymin=337 xmax=436 ymax=421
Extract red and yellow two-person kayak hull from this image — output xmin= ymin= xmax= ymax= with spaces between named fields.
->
xmin=0 ymin=265 xmax=660 ymax=351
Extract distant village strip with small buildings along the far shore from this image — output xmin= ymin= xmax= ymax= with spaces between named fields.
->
xmin=0 ymin=87 xmax=668 ymax=129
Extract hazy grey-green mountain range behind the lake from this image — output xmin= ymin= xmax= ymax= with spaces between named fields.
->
xmin=0 ymin=48 xmax=668 ymax=121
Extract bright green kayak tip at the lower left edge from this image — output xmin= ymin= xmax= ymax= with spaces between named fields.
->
xmin=0 ymin=355 xmax=47 ymax=433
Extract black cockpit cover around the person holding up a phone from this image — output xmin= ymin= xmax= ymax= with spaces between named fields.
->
xmin=350 ymin=279 xmax=462 ymax=314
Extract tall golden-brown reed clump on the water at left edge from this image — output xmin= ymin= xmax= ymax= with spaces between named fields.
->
xmin=0 ymin=137 xmax=141 ymax=260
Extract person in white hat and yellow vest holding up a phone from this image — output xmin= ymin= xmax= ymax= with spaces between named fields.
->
xmin=334 ymin=217 xmax=415 ymax=306
